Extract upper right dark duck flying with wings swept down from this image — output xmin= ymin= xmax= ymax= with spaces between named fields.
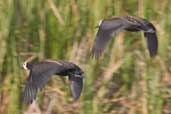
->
xmin=92 ymin=16 xmax=158 ymax=58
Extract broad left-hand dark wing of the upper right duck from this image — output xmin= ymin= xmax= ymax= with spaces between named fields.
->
xmin=91 ymin=18 xmax=125 ymax=58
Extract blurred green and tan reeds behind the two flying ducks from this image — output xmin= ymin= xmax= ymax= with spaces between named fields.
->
xmin=0 ymin=0 xmax=171 ymax=114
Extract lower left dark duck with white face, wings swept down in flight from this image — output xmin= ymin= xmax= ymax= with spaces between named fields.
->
xmin=23 ymin=60 xmax=84 ymax=103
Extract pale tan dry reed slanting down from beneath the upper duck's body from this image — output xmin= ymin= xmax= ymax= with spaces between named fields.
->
xmin=97 ymin=33 xmax=124 ymax=98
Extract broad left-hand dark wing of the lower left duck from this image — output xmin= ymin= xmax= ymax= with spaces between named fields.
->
xmin=23 ymin=62 xmax=61 ymax=103
